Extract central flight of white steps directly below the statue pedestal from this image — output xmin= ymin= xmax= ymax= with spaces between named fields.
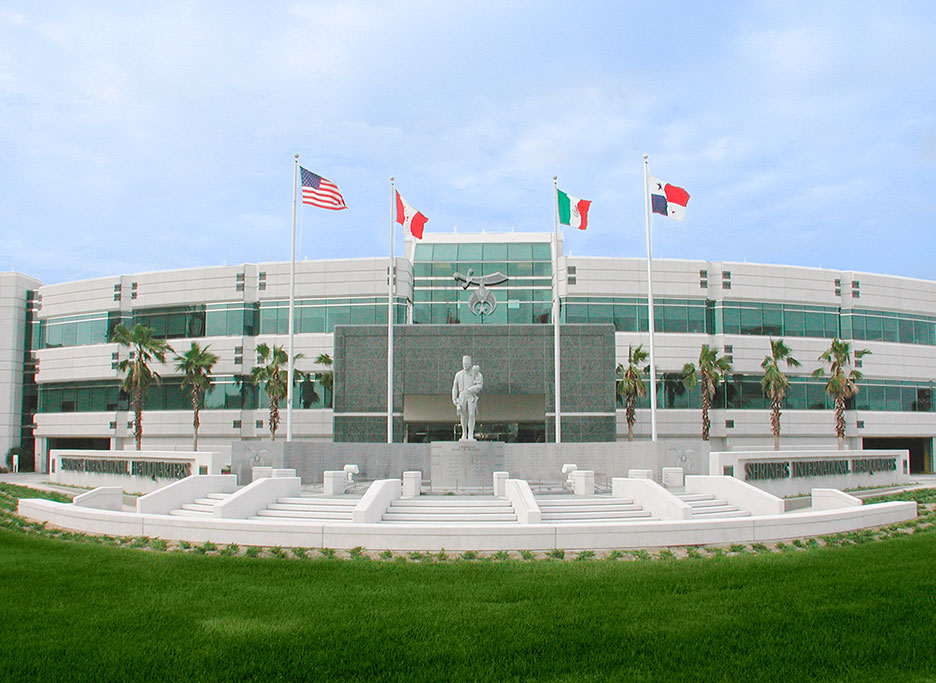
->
xmin=383 ymin=496 xmax=517 ymax=525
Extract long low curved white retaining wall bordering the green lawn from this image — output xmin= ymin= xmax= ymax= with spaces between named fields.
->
xmin=19 ymin=499 xmax=916 ymax=552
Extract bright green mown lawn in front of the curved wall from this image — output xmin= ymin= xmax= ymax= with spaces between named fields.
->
xmin=0 ymin=488 xmax=936 ymax=681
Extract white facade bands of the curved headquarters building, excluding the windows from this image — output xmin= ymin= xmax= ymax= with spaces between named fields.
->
xmin=9 ymin=233 xmax=936 ymax=471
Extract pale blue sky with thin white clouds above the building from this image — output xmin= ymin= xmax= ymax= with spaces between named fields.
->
xmin=0 ymin=0 xmax=936 ymax=284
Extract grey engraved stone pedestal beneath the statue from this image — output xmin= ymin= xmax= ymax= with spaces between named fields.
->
xmin=430 ymin=441 xmax=504 ymax=490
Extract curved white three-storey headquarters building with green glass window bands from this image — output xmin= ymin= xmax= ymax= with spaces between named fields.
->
xmin=0 ymin=233 xmax=936 ymax=472
